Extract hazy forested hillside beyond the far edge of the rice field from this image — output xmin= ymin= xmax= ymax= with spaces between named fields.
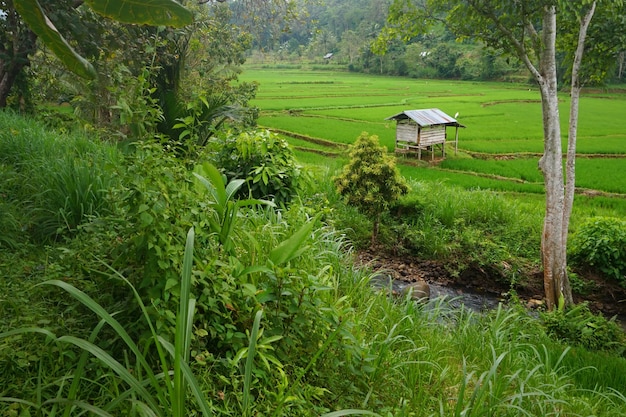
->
xmin=231 ymin=0 xmax=626 ymax=83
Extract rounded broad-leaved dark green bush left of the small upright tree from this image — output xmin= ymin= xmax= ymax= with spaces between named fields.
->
xmin=215 ymin=130 xmax=307 ymax=205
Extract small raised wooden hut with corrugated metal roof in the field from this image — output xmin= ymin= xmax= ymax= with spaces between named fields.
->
xmin=385 ymin=109 xmax=465 ymax=159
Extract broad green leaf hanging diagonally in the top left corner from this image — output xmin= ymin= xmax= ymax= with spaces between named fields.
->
xmin=14 ymin=0 xmax=97 ymax=78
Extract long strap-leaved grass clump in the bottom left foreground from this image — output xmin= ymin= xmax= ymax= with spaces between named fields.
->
xmin=0 ymin=229 xmax=212 ymax=417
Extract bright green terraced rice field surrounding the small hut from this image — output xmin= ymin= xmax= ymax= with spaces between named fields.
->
xmin=241 ymin=67 xmax=626 ymax=195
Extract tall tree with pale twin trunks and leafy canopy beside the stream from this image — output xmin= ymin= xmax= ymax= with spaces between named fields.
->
xmin=376 ymin=0 xmax=626 ymax=308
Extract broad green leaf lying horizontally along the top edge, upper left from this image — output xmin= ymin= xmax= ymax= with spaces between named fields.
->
xmin=85 ymin=0 xmax=193 ymax=27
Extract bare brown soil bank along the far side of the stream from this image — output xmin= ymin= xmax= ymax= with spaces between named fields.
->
xmin=357 ymin=250 xmax=626 ymax=323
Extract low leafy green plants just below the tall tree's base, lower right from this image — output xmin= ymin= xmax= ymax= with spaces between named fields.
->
xmin=541 ymin=303 xmax=626 ymax=355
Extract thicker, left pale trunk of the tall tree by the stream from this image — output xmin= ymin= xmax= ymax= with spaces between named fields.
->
xmin=538 ymin=6 xmax=573 ymax=309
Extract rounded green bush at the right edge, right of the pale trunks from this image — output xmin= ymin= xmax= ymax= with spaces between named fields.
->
xmin=569 ymin=217 xmax=626 ymax=285
